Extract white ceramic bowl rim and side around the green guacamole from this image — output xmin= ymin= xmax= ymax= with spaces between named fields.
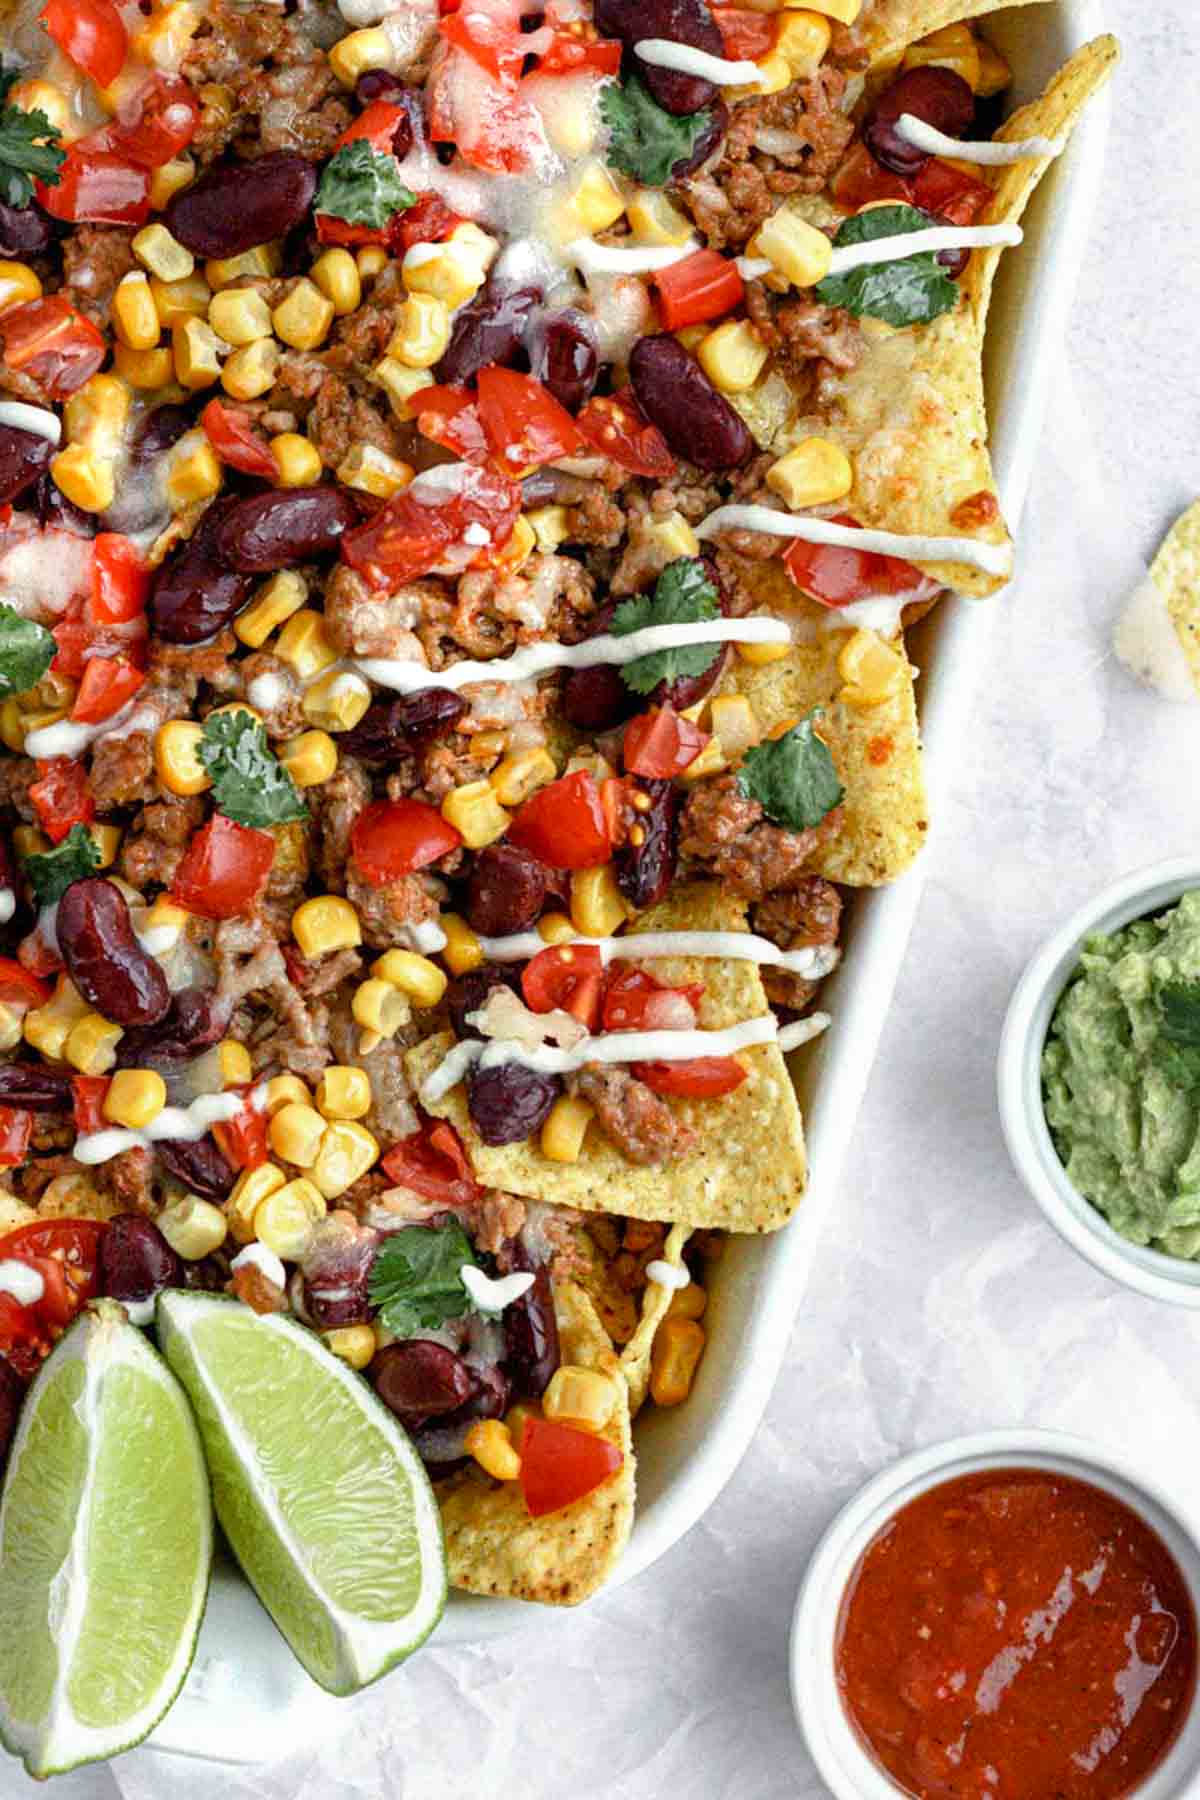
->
xmin=997 ymin=857 xmax=1200 ymax=1309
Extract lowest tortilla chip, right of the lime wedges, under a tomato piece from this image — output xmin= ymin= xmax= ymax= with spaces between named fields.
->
xmin=437 ymin=1282 xmax=635 ymax=1606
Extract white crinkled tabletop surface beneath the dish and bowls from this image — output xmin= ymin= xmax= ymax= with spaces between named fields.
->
xmin=0 ymin=0 xmax=1200 ymax=1800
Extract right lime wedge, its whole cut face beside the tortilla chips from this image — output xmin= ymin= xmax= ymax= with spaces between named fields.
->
xmin=158 ymin=1291 xmax=446 ymax=1694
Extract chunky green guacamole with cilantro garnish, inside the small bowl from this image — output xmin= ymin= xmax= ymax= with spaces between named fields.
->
xmin=1042 ymin=891 xmax=1200 ymax=1260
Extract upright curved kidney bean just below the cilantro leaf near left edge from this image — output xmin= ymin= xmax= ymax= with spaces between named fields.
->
xmin=56 ymin=875 xmax=171 ymax=1026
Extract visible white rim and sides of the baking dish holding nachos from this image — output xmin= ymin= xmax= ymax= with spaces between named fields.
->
xmin=151 ymin=0 xmax=1108 ymax=1762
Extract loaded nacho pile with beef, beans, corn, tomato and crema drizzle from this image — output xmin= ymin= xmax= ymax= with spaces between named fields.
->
xmin=0 ymin=0 xmax=1115 ymax=1604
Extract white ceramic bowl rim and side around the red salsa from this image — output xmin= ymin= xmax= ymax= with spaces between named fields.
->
xmin=790 ymin=1429 xmax=1200 ymax=1800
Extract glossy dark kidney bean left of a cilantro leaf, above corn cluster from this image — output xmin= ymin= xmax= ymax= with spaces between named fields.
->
xmin=164 ymin=149 xmax=317 ymax=256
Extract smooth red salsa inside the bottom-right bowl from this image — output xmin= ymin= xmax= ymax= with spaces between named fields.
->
xmin=837 ymin=1469 xmax=1196 ymax=1800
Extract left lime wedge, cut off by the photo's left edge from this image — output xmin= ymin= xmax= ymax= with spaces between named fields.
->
xmin=0 ymin=1301 xmax=212 ymax=1777
